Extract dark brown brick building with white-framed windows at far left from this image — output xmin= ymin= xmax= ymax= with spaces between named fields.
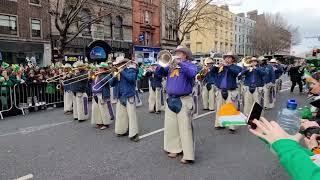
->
xmin=0 ymin=0 xmax=51 ymax=66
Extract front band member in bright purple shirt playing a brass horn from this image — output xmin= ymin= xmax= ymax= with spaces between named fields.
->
xmin=156 ymin=46 xmax=197 ymax=164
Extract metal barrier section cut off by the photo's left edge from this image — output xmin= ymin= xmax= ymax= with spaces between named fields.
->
xmin=0 ymin=85 xmax=14 ymax=119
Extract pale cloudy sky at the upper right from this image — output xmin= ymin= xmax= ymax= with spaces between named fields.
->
xmin=225 ymin=0 xmax=320 ymax=55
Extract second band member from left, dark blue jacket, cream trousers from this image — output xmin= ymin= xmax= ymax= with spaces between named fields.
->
xmin=72 ymin=61 xmax=89 ymax=122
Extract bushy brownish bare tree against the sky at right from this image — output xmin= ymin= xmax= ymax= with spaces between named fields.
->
xmin=251 ymin=13 xmax=301 ymax=54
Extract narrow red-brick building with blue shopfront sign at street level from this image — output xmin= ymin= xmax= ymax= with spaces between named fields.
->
xmin=132 ymin=0 xmax=162 ymax=63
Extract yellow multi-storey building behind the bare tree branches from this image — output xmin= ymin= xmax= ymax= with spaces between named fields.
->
xmin=182 ymin=5 xmax=235 ymax=55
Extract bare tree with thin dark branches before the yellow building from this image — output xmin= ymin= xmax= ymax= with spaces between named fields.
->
xmin=164 ymin=0 xmax=214 ymax=45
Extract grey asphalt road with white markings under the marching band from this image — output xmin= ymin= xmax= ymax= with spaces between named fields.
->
xmin=0 ymin=79 xmax=306 ymax=180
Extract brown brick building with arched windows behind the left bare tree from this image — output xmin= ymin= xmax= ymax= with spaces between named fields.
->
xmin=51 ymin=0 xmax=133 ymax=61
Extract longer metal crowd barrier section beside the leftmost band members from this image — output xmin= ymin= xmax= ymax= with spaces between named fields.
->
xmin=14 ymin=83 xmax=63 ymax=115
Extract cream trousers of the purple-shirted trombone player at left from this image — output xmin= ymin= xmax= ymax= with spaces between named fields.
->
xmin=91 ymin=93 xmax=111 ymax=125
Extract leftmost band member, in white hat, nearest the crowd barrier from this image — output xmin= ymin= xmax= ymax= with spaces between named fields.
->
xmin=63 ymin=63 xmax=73 ymax=115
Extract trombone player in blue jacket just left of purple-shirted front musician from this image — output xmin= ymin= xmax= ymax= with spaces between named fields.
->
xmin=110 ymin=57 xmax=139 ymax=142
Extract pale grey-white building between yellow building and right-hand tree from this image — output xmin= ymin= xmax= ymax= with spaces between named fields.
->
xmin=234 ymin=13 xmax=256 ymax=57
